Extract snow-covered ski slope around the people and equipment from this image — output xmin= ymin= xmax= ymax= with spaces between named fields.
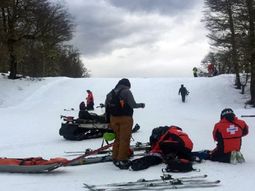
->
xmin=0 ymin=75 xmax=255 ymax=191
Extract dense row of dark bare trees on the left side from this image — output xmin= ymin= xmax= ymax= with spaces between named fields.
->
xmin=0 ymin=0 xmax=89 ymax=79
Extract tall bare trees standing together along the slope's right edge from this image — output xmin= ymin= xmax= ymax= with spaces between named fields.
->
xmin=203 ymin=0 xmax=255 ymax=106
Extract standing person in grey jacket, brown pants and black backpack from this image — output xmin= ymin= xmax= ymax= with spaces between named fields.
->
xmin=105 ymin=78 xmax=145 ymax=169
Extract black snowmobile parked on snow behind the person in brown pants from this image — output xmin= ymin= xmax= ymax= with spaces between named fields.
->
xmin=59 ymin=104 xmax=140 ymax=141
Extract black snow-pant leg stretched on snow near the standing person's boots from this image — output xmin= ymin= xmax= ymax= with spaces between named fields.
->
xmin=131 ymin=155 xmax=162 ymax=171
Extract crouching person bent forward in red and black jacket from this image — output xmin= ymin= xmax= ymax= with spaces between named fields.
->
xmin=131 ymin=126 xmax=193 ymax=170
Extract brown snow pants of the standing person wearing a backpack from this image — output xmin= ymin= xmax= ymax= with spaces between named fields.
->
xmin=110 ymin=116 xmax=133 ymax=160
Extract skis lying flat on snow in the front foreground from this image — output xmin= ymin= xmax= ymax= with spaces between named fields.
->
xmin=83 ymin=173 xmax=220 ymax=191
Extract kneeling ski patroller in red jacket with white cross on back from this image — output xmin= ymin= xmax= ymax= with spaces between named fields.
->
xmin=193 ymin=108 xmax=249 ymax=164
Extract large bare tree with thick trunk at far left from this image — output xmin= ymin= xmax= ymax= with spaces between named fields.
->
xmin=0 ymin=0 xmax=73 ymax=79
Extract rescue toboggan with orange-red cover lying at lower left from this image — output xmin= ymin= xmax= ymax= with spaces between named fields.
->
xmin=0 ymin=157 xmax=68 ymax=173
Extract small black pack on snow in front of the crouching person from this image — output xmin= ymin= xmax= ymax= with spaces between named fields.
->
xmin=165 ymin=158 xmax=195 ymax=172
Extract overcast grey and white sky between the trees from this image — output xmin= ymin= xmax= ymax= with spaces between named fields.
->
xmin=60 ymin=0 xmax=209 ymax=77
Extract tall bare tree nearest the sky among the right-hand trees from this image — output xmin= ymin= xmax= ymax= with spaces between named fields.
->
xmin=203 ymin=0 xmax=241 ymax=89
